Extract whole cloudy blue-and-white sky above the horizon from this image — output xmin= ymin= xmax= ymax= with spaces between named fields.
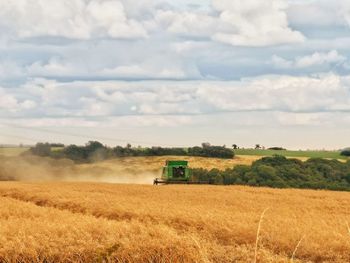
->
xmin=0 ymin=0 xmax=350 ymax=150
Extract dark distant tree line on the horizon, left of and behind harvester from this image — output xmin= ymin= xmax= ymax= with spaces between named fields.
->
xmin=29 ymin=141 xmax=234 ymax=163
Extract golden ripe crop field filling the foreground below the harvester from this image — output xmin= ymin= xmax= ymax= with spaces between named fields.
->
xmin=0 ymin=182 xmax=350 ymax=262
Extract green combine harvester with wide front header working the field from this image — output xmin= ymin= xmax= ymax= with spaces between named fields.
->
xmin=153 ymin=161 xmax=214 ymax=185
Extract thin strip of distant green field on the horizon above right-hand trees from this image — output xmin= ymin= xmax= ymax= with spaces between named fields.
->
xmin=235 ymin=149 xmax=347 ymax=159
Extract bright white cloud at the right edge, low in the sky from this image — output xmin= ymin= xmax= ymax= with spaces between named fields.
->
xmin=199 ymin=75 xmax=350 ymax=112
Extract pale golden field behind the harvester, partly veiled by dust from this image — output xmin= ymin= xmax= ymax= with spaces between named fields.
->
xmin=0 ymin=156 xmax=261 ymax=184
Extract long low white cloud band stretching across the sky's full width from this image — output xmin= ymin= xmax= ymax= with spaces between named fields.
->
xmin=1 ymin=74 xmax=350 ymax=118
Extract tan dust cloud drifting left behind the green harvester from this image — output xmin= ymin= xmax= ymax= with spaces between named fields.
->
xmin=0 ymin=155 xmax=160 ymax=184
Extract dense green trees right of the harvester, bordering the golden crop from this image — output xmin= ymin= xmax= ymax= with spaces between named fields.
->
xmin=192 ymin=155 xmax=350 ymax=191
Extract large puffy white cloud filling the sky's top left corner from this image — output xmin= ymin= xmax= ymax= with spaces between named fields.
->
xmin=0 ymin=0 xmax=147 ymax=39
